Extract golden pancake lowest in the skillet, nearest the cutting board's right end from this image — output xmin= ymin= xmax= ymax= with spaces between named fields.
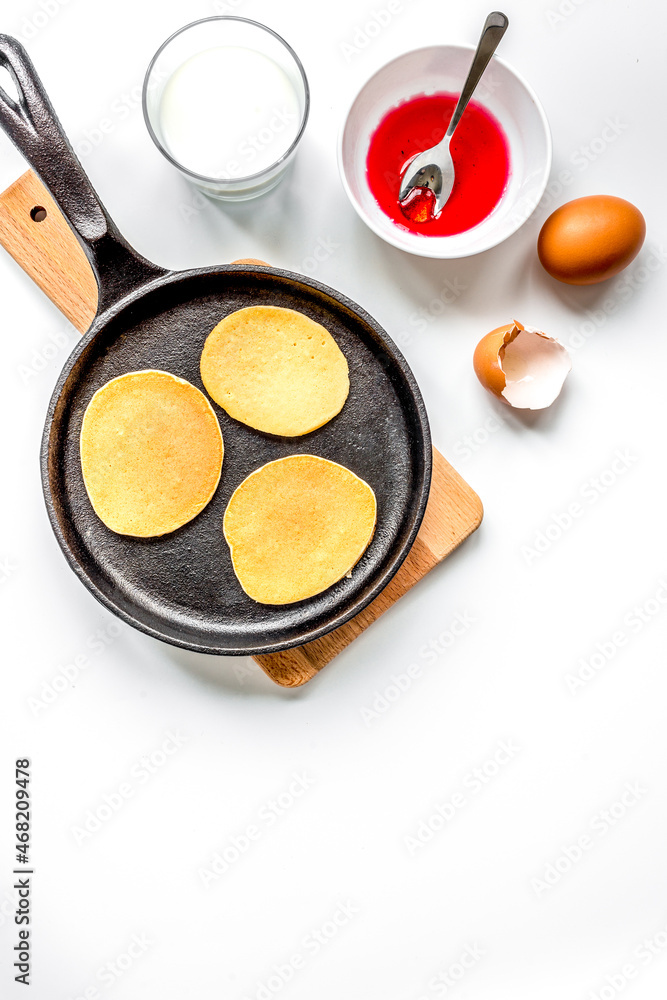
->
xmin=223 ymin=455 xmax=377 ymax=604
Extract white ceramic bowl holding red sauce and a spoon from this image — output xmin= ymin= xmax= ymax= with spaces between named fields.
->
xmin=338 ymin=45 xmax=551 ymax=258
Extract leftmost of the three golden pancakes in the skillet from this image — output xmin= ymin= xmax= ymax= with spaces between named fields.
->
xmin=81 ymin=371 xmax=224 ymax=538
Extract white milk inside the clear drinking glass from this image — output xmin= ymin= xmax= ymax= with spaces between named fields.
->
xmin=159 ymin=45 xmax=301 ymax=178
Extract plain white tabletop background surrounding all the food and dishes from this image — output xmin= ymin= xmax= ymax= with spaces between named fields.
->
xmin=0 ymin=0 xmax=667 ymax=1000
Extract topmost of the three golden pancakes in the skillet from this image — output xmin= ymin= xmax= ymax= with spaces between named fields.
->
xmin=201 ymin=306 xmax=350 ymax=437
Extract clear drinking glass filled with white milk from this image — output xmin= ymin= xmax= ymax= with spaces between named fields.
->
xmin=143 ymin=17 xmax=310 ymax=201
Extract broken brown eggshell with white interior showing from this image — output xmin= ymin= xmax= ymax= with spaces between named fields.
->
xmin=473 ymin=320 xmax=572 ymax=410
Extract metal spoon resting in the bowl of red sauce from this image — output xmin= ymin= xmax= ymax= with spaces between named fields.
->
xmin=398 ymin=10 xmax=509 ymax=218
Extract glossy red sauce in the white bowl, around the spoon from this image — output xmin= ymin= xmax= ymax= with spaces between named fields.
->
xmin=366 ymin=94 xmax=510 ymax=236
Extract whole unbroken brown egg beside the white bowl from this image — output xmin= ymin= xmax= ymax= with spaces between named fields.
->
xmin=537 ymin=194 xmax=646 ymax=285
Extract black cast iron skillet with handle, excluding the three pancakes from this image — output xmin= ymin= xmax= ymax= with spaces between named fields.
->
xmin=0 ymin=35 xmax=431 ymax=655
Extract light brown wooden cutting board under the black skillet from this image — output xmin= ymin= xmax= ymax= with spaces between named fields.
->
xmin=0 ymin=170 xmax=483 ymax=687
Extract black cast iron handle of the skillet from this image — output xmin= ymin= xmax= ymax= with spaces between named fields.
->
xmin=0 ymin=34 xmax=165 ymax=314
